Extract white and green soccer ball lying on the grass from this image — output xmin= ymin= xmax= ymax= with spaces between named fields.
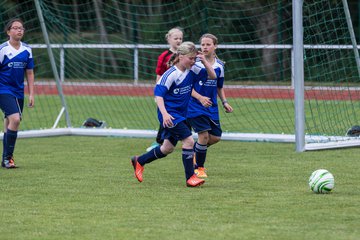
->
xmin=309 ymin=169 xmax=335 ymax=193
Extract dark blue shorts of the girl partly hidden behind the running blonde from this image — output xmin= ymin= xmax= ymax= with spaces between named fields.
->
xmin=187 ymin=115 xmax=222 ymax=137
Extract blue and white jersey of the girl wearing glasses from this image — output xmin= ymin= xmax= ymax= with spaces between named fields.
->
xmin=0 ymin=41 xmax=34 ymax=99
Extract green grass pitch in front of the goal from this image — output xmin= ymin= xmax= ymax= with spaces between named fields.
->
xmin=0 ymin=136 xmax=360 ymax=240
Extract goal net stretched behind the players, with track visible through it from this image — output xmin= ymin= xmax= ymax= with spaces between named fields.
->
xmin=0 ymin=0 xmax=360 ymax=149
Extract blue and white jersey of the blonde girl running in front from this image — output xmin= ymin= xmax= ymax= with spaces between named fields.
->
xmin=154 ymin=65 xmax=207 ymax=124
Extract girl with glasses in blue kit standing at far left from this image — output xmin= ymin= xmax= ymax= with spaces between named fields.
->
xmin=0 ymin=19 xmax=34 ymax=168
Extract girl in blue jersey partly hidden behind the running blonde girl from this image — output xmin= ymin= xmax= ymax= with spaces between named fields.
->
xmin=187 ymin=33 xmax=233 ymax=178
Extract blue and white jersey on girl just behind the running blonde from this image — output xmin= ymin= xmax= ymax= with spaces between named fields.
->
xmin=187 ymin=58 xmax=224 ymax=120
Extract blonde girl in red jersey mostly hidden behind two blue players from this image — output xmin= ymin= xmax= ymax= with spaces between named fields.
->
xmin=146 ymin=27 xmax=184 ymax=151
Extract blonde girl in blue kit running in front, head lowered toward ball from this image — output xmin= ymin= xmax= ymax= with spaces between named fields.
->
xmin=131 ymin=42 xmax=216 ymax=187
